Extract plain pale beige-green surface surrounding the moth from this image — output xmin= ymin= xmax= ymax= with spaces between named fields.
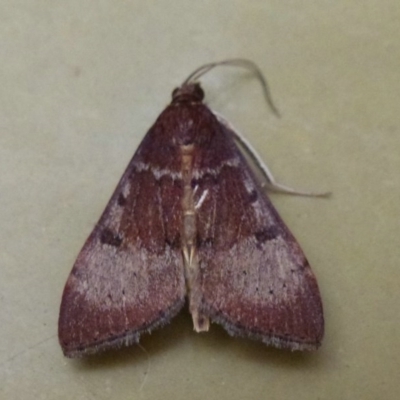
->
xmin=0 ymin=0 xmax=400 ymax=400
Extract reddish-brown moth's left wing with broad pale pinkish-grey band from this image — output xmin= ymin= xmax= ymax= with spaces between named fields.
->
xmin=59 ymin=128 xmax=186 ymax=357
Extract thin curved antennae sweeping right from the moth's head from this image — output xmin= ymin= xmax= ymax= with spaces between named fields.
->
xmin=182 ymin=58 xmax=280 ymax=117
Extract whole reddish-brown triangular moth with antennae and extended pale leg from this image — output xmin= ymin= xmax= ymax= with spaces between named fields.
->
xmin=58 ymin=59 xmax=324 ymax=357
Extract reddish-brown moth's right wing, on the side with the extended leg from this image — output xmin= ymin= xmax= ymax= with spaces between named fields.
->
xmin=191 ymin=119 xmax=324 ymax=350
